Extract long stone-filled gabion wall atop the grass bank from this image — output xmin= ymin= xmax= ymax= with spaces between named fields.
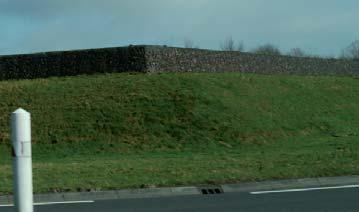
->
xmin=0 ymin=45 xmax=359 ymax=80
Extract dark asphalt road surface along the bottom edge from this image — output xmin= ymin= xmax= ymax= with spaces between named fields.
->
xmin=0 ymin=188 xmax=359 ymax=212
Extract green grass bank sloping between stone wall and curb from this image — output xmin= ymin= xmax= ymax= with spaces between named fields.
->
xmin=0 ymin=73 xmax=359 ymax=194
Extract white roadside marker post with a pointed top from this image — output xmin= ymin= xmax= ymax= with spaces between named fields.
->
xmin=11 ymin=108 xmax=34 ymax=212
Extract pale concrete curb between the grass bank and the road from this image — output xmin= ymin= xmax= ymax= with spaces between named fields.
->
xmin=0 ymin=175 xmax=359 ymax=205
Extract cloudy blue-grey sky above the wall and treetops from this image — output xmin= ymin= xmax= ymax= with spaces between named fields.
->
xmin=0 ymin=0 xmax=359 ymax=56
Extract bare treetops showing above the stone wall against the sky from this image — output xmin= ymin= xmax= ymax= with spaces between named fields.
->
xmin=184 ymin=37 xmax=359 ymax=60
